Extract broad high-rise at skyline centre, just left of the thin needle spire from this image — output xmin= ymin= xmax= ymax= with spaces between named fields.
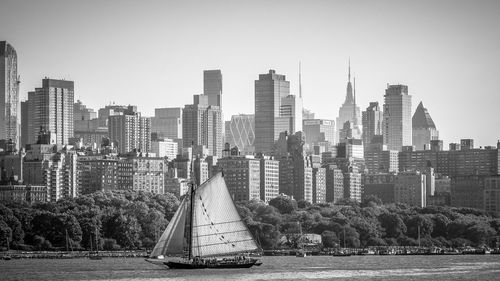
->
xmin=255 ymin=70 xmax=290 ymax=153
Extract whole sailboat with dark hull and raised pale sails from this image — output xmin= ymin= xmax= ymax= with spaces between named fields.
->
xmin=146 ymin=173 xmax=262 ymax=269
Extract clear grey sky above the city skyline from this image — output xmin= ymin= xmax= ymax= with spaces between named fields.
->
xmin=0 ymin=0 xmax=500 ymax=146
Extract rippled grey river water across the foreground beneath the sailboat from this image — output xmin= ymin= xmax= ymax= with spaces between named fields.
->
xmin=0 ymin=255 xmax=500 ymax=281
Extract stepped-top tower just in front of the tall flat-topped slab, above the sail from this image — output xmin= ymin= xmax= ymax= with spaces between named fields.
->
xmin=182 ymin=95 xmax=223 ymax=157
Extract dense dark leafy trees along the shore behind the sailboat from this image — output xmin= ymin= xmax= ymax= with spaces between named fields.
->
xmin=0 ymin=190 xmax=500 ymax=250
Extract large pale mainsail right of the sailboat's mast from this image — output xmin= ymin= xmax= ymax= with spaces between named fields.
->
xmin=191 ymin=173 xmax=259 ymax=257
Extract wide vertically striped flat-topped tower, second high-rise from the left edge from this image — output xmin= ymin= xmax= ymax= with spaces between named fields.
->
xmin=28 ymin=78 xmax=75 ymax=145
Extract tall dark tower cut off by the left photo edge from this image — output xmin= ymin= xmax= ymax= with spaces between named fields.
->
xmin=0 ymin=41 xmax=20 ymax=148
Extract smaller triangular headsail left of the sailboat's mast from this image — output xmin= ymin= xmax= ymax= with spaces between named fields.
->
xmin=150 ymin=198 xmax=189 ymax=258
